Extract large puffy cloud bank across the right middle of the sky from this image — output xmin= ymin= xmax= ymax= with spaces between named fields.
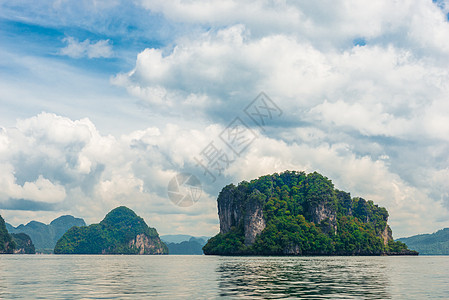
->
xmin=113 ymin=25 xmax=449 ymax=138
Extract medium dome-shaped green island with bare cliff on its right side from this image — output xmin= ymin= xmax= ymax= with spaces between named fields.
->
xmin=54 ymin=206 xmax=168 ymax=254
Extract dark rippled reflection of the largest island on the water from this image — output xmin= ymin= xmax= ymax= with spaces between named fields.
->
xmin=217 ymin=257 xmax=391 ymax=299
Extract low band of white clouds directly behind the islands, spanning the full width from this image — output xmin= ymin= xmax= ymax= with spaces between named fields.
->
xmin=0 ymin=113 xmax=449 ymax=235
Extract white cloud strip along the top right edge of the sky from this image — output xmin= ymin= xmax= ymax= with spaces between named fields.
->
xmin=141 ymin=0 xmax=449 ymax=53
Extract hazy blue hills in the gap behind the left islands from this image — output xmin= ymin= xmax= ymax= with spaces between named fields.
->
xmin=6 ymin=215 xmax=86 ymax=254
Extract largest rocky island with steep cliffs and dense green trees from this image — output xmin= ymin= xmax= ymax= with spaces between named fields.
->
xmin=203 ymin=171 xmax=418 ymax=255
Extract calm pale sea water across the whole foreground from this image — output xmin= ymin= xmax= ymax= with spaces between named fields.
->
xmin=0 ymin=255 xmax=449 ymax=299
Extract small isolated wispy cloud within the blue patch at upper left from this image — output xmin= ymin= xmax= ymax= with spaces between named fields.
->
xmin=59 ymin=36 xmax=113 ymax=58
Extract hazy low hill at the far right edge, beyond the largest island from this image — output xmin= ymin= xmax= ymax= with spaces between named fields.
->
xmin=397 ymin=228 xmax=449 ymax=255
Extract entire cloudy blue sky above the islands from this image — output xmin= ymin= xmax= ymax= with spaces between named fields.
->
xmin=0 ymin=0 xmax=449 ymax=238
